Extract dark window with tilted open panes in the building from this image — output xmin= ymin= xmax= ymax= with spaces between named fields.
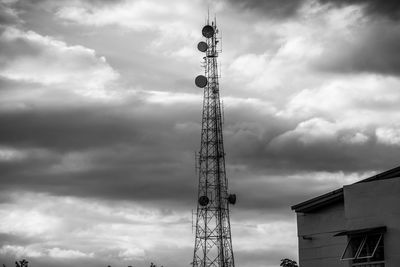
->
xmin=341 ymin=233 xmax=385 ymax=267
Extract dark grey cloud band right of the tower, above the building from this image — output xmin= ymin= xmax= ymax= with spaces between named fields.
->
xmin=224 ymin=103 xmax=400 ymax=175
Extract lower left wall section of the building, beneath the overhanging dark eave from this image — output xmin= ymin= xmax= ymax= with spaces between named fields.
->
xmin=297 ymin=202 xmax=348 ymax=267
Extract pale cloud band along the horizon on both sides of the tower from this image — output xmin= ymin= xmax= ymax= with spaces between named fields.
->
xmin=0 ymin=191 xmax=296 ymax=266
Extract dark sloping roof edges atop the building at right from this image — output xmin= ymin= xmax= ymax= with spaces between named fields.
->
xmin=292 ymin=166 xmax=400 ymax=213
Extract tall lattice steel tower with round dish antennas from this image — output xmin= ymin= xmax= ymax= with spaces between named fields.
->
xmin=192 ymin=17 xmax=236 ymax=267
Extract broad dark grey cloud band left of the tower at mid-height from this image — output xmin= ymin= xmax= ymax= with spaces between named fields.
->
xmin=0 ymin=101 xmax=197 ymax=206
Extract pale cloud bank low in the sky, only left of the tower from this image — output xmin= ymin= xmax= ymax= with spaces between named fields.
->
xmin=0 ymin=192 xmax=191 ymax=266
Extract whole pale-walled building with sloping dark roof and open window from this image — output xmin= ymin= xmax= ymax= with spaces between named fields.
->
xmin=292 ymin=167 xmax=400 ymax=267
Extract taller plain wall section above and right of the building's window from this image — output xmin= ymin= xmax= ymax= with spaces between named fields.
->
xmin=342 ymin=178 xmax=400 ymax=267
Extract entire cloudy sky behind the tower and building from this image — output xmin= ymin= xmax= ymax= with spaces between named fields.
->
xmin=0 ymin=0 xmax=400 ymax=267
